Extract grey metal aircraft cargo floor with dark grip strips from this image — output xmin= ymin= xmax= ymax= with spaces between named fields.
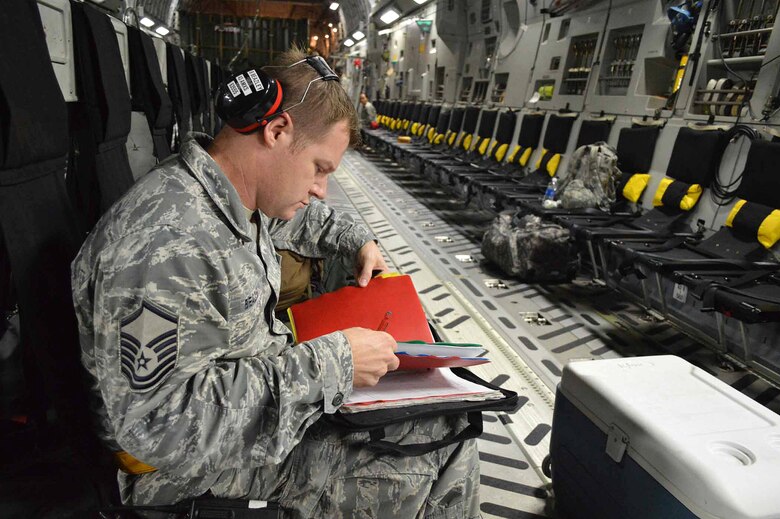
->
xmin=336 ymin=147 xmax=780 ymax=519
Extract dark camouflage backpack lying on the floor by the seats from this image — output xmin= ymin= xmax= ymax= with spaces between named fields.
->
xmin=482 ymin=212 xmax=578 ymax=281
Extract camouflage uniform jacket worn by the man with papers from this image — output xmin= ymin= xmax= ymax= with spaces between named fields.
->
xmin=72 ymin=134 xmax=373 ymax=503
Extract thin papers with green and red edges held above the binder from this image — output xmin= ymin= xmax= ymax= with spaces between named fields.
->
xmin=396 ymin=341 xmax=490 ymax=370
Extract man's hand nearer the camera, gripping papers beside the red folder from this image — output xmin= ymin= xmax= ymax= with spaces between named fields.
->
xmin=343 ymin=328 xmax=398 ymax=387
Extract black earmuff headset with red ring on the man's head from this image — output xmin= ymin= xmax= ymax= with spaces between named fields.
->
xmin=214 ymin=56 xmax=339 ymax=134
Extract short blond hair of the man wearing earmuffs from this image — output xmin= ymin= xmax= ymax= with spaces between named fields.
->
xmin=265 ymin=47 xmax=360 ymax=146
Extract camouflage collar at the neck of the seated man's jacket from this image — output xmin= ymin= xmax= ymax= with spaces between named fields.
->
xmin=179 ymin=132 xmax=253 ymax=241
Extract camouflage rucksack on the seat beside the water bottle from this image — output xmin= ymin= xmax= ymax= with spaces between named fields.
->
xmin=557 ymin=142 xmax=621 ymax=211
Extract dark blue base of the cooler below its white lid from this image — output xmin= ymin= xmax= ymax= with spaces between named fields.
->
xmin=550 ymin=390 xmax=696 ymax=519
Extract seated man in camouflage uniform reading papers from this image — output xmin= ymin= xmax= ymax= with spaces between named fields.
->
xmin=73 ymin=47 xmax=479 ymax=518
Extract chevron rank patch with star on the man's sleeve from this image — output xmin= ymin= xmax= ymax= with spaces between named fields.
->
xmin=119 ymin=300 xmax=179 ymax=392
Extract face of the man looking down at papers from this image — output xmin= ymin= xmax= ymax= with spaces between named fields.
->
xmin=264 ymin=121 xmax=349 ymax=220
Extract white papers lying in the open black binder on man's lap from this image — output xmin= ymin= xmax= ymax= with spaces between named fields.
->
xmin=341 ymin=368 xmax=503 ymax=413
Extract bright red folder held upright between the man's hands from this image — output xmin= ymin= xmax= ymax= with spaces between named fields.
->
xmin=287 ymin=276 xmax=433 ymax=342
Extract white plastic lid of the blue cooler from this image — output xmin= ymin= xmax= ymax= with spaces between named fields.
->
xmin=560 ymin=355 xmax=780 ymax=519
